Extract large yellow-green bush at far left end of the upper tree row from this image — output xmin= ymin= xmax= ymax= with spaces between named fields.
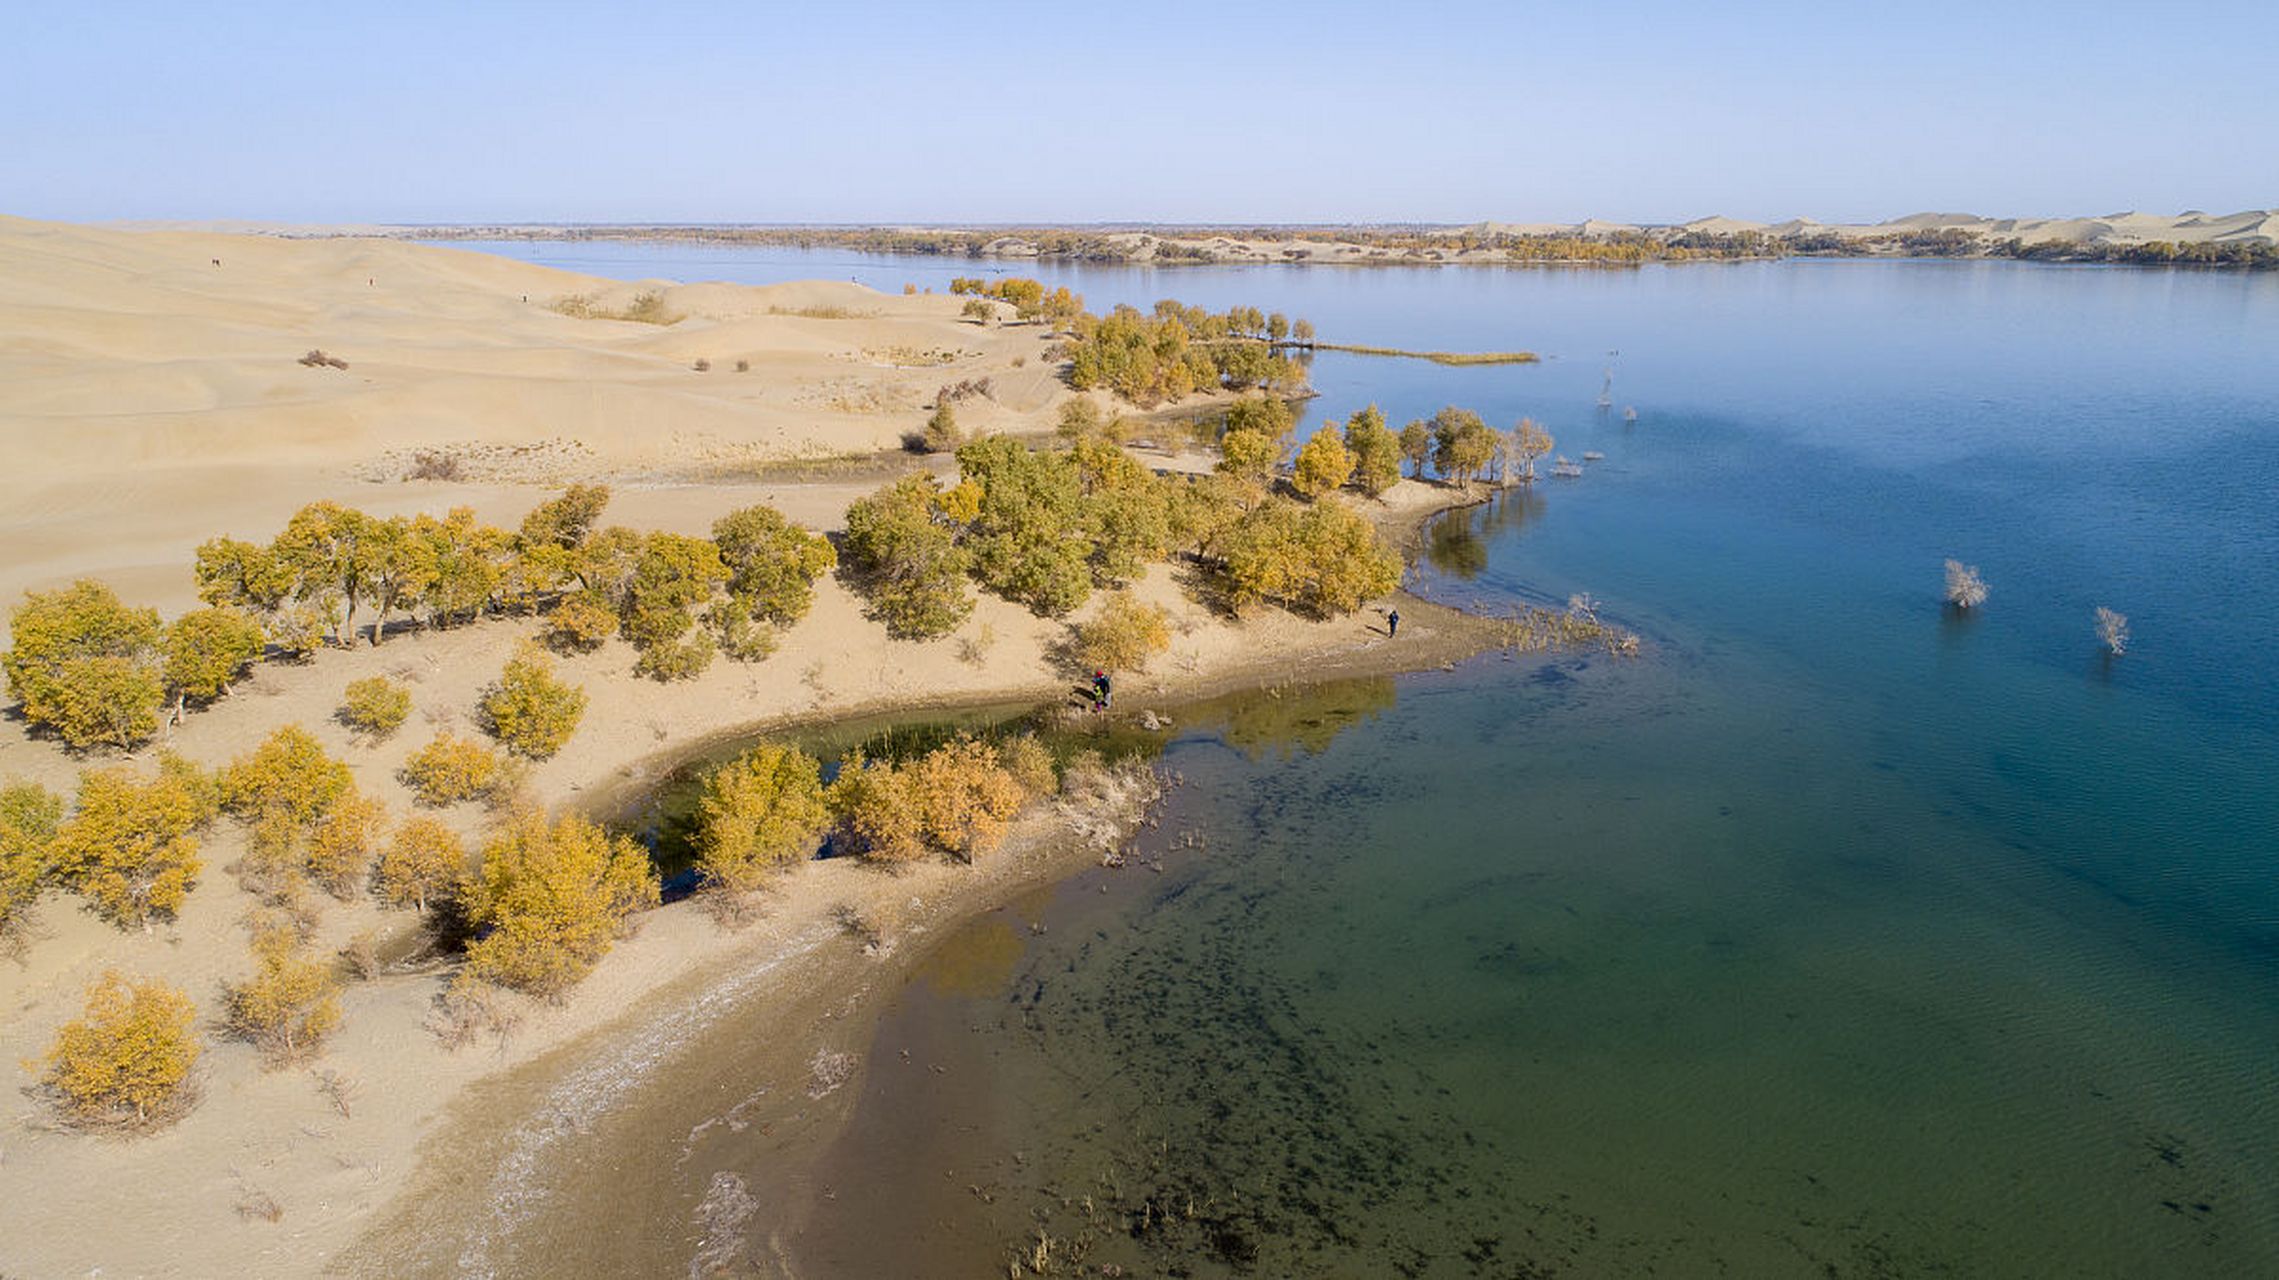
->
xmin=0 ymin=579 xmax=166 ymax=747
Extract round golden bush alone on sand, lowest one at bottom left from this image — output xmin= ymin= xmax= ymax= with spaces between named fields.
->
xmin=41 ymin=970 xmax=198 ymax=1130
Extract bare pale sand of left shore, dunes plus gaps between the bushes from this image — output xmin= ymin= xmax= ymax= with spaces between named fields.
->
xmin=0 ymin=219 xmax=1531 ymax=1275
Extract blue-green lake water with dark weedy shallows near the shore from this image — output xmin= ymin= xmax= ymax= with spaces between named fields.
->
xmin=435 ymin=244 xmax=2279 ymax=1275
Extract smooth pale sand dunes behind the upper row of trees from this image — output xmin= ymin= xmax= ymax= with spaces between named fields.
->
xmin=0 ymin=219 xmax=1067 ymax=613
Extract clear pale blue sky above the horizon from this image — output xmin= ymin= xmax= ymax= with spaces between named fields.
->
xmin=0 ymin=0 xmax=2279 ymax=223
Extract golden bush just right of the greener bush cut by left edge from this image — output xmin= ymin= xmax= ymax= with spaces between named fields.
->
xmin=48 ymin=765 xmax=212 ymax=929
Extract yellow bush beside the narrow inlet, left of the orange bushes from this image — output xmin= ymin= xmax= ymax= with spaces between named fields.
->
xmin=697 ymin=742 xmax=830 ymax=893
